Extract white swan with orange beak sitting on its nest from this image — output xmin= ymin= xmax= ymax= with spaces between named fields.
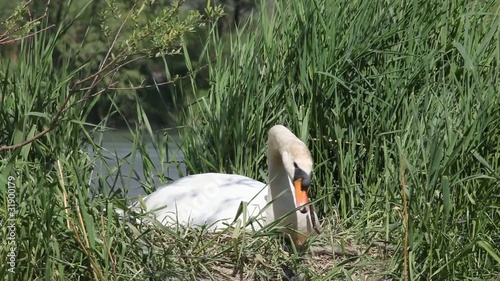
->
xmin=132 ymin=125 xmax=319 ymax=245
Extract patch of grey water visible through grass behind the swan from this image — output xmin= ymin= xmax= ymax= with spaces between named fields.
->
xmin=89 ymin=130 xmax=185 ymax=197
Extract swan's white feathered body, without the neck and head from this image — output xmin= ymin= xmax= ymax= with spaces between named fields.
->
xmin=135 ymin=173 xmax=267 ymax=229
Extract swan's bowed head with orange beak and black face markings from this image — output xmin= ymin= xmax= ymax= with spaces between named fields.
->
xmin=268 ymin=125 xmax=313 ymax=213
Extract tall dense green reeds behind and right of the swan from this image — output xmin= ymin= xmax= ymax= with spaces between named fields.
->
xmin=182 ymin=0 xmax=500 ymax=280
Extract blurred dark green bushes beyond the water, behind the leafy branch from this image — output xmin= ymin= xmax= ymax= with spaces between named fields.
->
xmin=0 ymin=0 xmax=255 ymax=127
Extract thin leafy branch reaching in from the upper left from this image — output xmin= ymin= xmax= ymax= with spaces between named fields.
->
xmin=0 ymin=0 xmax=222 ymax=151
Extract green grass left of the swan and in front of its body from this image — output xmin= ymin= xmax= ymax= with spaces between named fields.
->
xmin=0 ymin=6 xmax=332 ymax=281
